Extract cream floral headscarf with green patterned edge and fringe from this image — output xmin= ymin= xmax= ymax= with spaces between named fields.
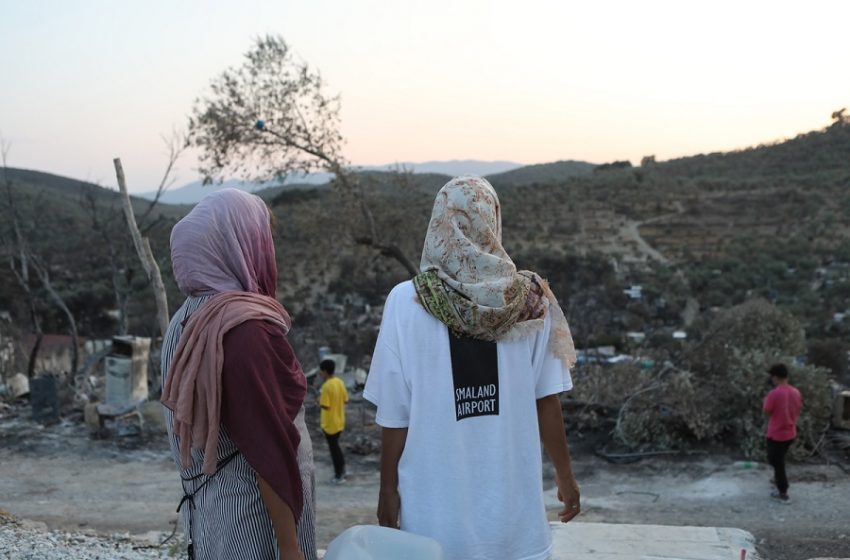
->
xmin=413 ymin=176 xmax=575 ymax=367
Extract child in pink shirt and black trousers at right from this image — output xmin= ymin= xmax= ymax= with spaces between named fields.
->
xmin=764 ymin=364 xmax=803 ymax=504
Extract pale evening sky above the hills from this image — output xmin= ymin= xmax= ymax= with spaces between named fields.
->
xmin=0 ymin=0 xmax=850 ymax=191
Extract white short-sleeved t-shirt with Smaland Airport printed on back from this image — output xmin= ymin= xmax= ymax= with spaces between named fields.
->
xmin=363 ymin=281 xmax=572 ymax=560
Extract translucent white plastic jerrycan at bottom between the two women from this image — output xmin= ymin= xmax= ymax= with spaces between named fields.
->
xmin=324 ymin=525 xmax=444 ymax=560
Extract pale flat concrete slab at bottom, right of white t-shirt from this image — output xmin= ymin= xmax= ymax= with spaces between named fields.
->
xmin=551 ymin=522 xmax=758 ymax=560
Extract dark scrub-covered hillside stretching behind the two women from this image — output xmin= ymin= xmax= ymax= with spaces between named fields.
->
xmin=0 ymin=119 xmax=850 ymax=372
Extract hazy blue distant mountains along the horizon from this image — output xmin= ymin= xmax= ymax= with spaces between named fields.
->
xmin=136 ymin=159 xmax=528 ymax=204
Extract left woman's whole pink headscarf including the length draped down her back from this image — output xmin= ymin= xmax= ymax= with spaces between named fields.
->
xmin=162 ymin=189 xmax=303 ymax=474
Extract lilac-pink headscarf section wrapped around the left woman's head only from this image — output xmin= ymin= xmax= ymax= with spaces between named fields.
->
xmin=171 ymin=189 xmax=277 ymax=297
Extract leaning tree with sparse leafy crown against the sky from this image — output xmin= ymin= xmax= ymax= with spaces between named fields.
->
xmin=189 ymin=36 xmax=418 ymax=275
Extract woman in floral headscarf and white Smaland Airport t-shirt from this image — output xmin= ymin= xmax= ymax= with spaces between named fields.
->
xmin=364 ymin=177 xmax=580 ymax=560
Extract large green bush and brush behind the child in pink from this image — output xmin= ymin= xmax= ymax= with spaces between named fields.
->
xmin=573 ymin=300 xmax=830 ymax=458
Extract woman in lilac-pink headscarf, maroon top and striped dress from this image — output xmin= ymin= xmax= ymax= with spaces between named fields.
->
xmin=162 ymin=189 xmax=316 ymax=560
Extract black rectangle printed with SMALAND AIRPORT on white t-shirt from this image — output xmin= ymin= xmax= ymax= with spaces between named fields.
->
xmin=449 ymin=333 xmax=499 ymax=422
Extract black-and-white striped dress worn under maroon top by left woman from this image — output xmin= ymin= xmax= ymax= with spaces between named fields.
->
xmin=162 ymin=296 xmax=317 ymax=560
